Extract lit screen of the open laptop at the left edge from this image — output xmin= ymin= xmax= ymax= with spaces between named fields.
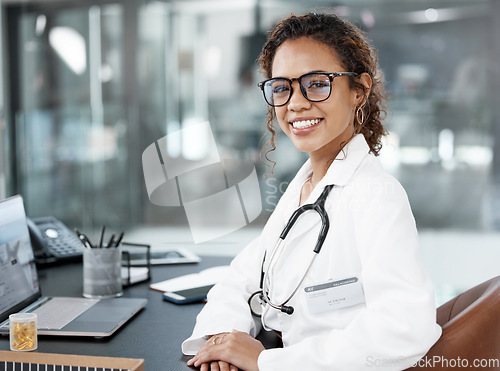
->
xmin=0 ymin=195 xmax=41 ymax=322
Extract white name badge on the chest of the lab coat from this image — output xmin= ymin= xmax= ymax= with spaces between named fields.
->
xmin=304 ymin=277 xmax=365 ymax=314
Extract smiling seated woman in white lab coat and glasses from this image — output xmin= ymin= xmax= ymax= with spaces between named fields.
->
xmin=182 ymin=14 xmax=441 ymax=371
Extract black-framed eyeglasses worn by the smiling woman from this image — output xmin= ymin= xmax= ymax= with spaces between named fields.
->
xmin=258 ymin=72 xmax=358 ymax=107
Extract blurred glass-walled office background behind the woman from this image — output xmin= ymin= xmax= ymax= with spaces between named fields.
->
xmin=0 ymin=0 xmax=500 ymax=306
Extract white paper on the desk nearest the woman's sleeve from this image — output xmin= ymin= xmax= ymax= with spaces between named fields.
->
xmin=149 ymin=265 xmax=229 ymax=292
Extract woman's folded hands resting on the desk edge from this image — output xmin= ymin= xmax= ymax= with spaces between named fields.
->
xmin=187 ymin=330 xmax=264 ymax=371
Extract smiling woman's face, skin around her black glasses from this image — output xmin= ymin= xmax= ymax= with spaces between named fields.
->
xmin=272 ymin=37 xmax=363 ymax=157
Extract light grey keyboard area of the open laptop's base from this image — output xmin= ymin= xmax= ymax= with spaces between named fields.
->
xmin=32 ymin=297 xmax=99 ymax=330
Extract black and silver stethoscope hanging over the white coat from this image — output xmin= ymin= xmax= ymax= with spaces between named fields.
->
xmin=248 ymin=184 xmax=334 ymax=317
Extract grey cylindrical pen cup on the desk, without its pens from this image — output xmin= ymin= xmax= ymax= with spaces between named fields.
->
xmin=83 ymin=247 xmax=123 ymax=298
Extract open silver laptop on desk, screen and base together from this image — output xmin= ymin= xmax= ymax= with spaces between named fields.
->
xmin=0 ymin=195 xmax=147 ymax=337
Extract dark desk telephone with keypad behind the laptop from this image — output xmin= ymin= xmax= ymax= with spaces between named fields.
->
xmin=26 ymin=216 xmax=83 ymax=265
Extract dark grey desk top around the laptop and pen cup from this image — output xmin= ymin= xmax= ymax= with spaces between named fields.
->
xmin=0 ymin=257 xmax=231 ymax=371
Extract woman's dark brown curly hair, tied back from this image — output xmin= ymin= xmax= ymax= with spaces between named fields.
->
xmin=258 ymin=13 xmax=386 ymax=167
